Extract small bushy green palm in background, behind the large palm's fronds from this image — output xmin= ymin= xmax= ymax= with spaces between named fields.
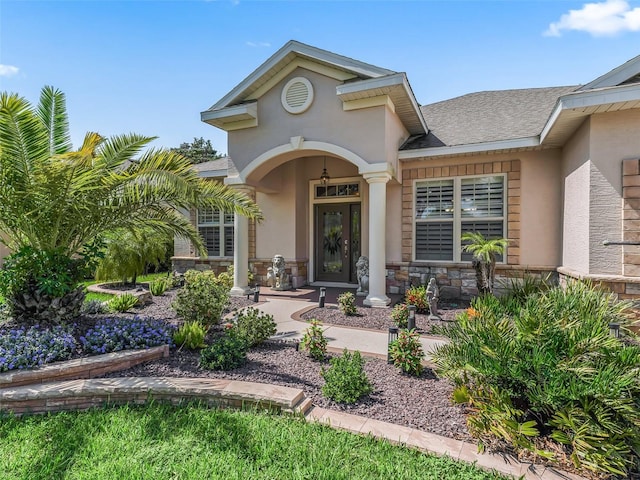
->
xmin=96 ymin=228 xmax=173 ymax=285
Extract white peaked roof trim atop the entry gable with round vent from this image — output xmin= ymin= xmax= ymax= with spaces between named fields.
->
xmin=208 ymin=40 xmax=396 ymax=110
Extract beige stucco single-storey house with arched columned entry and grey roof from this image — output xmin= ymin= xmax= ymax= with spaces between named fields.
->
xmin=173 ymin=41 xmax=640 ymax=306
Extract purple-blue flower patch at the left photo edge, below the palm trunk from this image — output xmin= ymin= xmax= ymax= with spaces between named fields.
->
xmin=0 ymin=325 xmax=77 ymax=372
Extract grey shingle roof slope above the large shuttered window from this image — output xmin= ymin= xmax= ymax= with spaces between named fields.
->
xmin=401 ymin=86 xmax=577 ymax=150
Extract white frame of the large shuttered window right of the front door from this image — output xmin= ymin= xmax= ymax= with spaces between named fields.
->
xmin=411 ymin=173 xmax=509 ymax=265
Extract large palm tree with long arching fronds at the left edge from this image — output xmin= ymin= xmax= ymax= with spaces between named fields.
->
xmin=0 ymin=87 xmax=261 ymax=321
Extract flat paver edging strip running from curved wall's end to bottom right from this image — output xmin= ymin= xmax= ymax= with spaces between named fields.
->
xmin=306 ymin=406 xmax=586 ymax=480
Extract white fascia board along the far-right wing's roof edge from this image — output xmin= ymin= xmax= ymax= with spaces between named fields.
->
xmin=540 ymin=83 xmax=640 ymax=143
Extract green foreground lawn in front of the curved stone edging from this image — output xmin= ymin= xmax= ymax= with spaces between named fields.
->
xmin=0 ymin=404 xmax=506 ymax=480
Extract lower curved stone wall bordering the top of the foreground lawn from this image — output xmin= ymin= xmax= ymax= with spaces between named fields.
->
xmin=0 ymin=377 xmax=311 ymax=415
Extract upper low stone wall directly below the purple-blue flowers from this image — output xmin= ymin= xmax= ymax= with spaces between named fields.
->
xmin=0 ymin=345 xmax=169 ymax=389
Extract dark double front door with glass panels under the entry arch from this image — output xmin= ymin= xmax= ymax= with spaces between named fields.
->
xmin=315 ymin=203 xmax=360 ymax=283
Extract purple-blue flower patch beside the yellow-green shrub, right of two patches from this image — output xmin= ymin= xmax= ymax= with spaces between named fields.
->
xmin=80 ymin=316 xmax=174 ymax=354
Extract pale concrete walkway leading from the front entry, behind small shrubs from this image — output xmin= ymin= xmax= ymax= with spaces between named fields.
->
xmin=249 ymin=296 xmax=445 ymax=360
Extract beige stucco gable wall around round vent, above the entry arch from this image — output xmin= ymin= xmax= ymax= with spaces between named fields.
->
xmin=229 ymin=68 xmax=387 ymax=171
